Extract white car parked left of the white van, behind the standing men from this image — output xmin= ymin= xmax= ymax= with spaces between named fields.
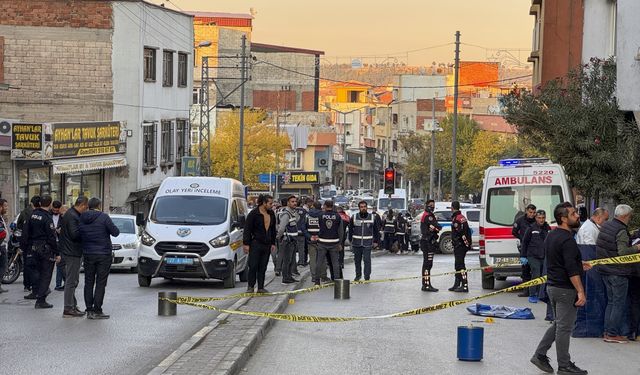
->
xmin=109 ymin=215 xmax=140 ymax=272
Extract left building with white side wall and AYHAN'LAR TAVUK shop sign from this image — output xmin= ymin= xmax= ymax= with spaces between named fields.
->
xmin=0 ymin=0 xmax=193 ymax=217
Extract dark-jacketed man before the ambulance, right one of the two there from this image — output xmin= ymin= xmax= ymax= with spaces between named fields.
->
xmin=520 ymin=210 xmax=551 ymax=303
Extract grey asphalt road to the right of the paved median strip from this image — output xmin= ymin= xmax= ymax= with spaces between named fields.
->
xmin=243 ymin=253 xmax=640 ymax=375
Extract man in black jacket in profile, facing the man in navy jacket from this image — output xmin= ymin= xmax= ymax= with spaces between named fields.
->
xmin=58 ymin=195 xmax=89 ymax=318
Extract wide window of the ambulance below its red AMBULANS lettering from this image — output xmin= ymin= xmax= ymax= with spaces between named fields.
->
xmin=486 ymin=185 xmax=563 ymax=226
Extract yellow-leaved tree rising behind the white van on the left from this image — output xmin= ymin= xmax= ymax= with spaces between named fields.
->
xmin=211 ymin=110 xmax=290 ymax=185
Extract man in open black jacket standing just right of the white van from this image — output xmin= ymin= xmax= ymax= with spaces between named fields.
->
xmin=242 ymin=194 xmax=276 ymax=293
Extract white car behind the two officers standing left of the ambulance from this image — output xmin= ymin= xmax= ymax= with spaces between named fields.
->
xmin=410 ymin=207 xmax=481 ymax=254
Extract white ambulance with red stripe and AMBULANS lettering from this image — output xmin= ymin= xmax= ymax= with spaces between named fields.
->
xmin=480 ymin=158 xmax=572 ymax=289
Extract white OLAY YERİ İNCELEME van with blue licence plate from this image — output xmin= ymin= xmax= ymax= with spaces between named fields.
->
xmin=136 ymin=177 xmax=248 ymax=288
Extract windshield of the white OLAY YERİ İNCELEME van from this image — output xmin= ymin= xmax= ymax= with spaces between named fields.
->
xmin=151 ymin=195 xmax=228 ymax=225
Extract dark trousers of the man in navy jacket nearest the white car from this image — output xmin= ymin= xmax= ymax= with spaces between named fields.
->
xmin=84 ymin=254 xmax=112 ymax=313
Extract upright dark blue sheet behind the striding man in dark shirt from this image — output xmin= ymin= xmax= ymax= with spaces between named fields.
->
xmin=572 ymin=245 xmax=607 ymax=337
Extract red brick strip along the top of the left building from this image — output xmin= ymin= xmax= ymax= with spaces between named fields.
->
xmin=0 ymin=0 xmax=113 ymax=29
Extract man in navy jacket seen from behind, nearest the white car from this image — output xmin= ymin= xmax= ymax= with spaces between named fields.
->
xmin=80 ymin=198 xmax=120 ymax=319
